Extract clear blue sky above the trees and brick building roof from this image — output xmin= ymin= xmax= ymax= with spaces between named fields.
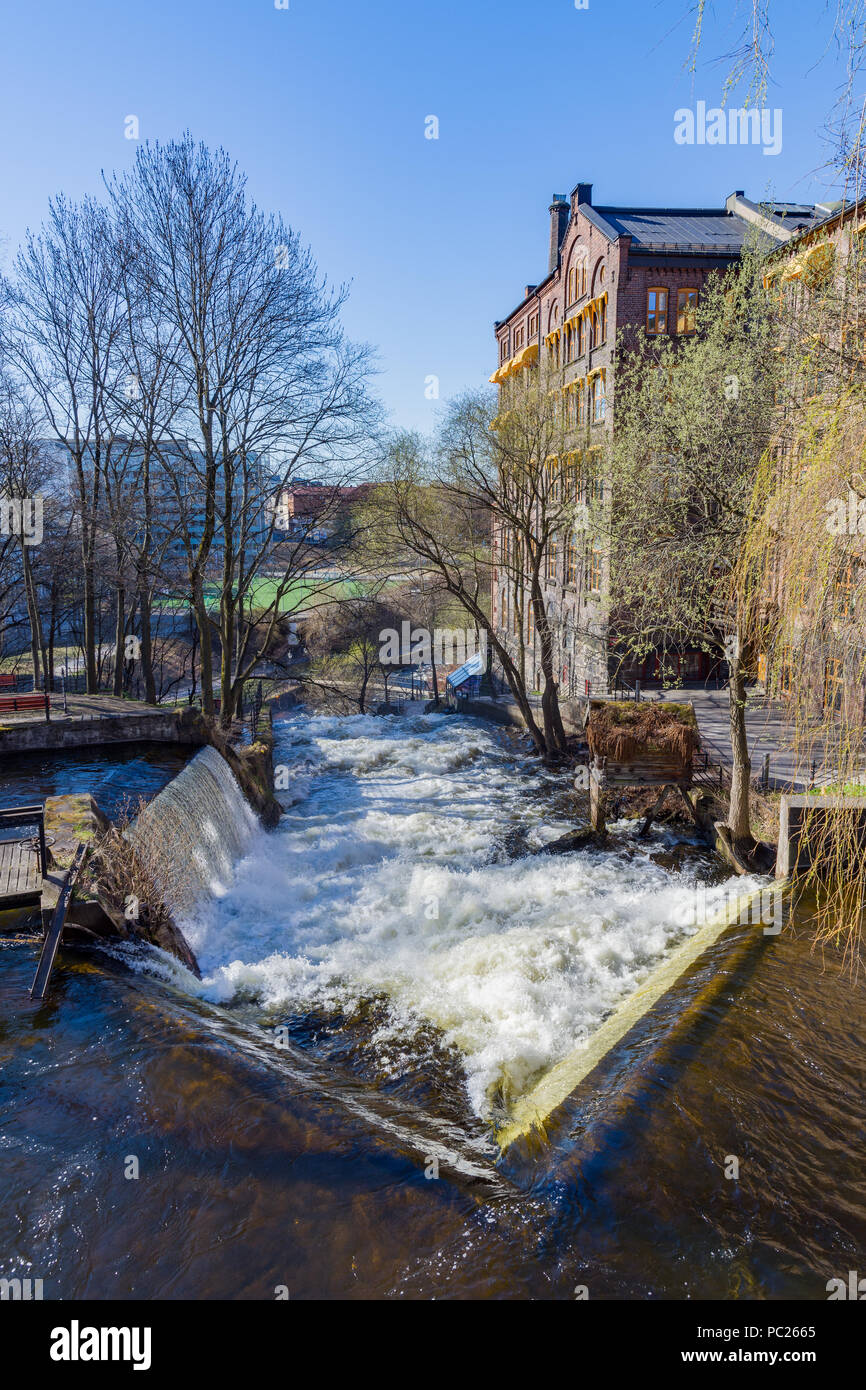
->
xmin=0 ymin=0 xmax=856 ymax=430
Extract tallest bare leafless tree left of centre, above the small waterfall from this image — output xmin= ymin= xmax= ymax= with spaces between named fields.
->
xmin=108 ymin=136 xmax=371 ymax=723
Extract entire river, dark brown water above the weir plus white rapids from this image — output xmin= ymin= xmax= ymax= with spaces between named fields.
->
xmin=0 ymin=717 xmax=866 ymax=1300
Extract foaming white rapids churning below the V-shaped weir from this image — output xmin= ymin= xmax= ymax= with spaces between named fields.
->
xmin=166 ymin=716 xmax=750 ymax=1115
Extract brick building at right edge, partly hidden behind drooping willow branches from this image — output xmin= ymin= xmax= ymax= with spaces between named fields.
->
xmin=756 ymin=199 xmax=866 ymax=726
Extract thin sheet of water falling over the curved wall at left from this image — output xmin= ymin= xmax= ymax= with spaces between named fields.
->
xmin=129 ymin=748 xmax=259 ymax=916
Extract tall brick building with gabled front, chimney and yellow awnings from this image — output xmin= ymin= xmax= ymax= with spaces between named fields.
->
xmin=491 ymin=183 xmax=830 ymax=696
